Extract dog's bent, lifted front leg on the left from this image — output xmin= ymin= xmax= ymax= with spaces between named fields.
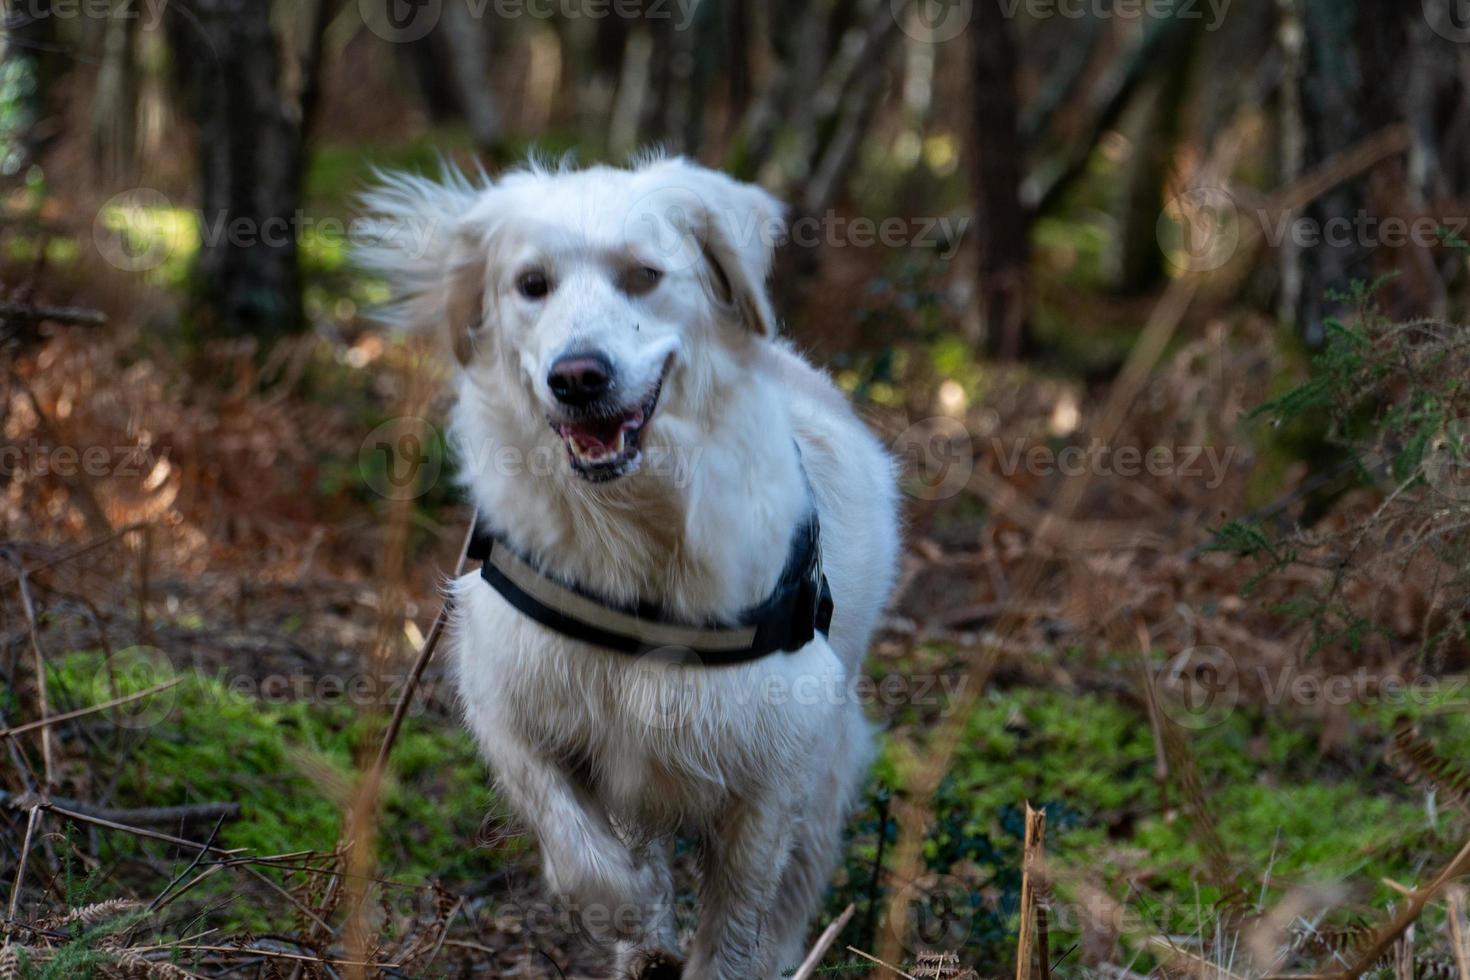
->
xmin=482 ymin=733 xmax=679 ymax=980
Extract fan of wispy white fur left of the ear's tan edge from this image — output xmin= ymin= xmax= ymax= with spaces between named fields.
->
xmin=353 ymin=162 xmax=491 ymax=346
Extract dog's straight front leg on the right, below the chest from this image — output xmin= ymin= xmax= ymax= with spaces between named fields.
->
xmin=685 ymin=799 xmax=792 ymax=980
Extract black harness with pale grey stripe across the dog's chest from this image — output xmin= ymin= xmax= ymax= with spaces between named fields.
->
xmin=466 ymin=511 xmax=832 ymax=667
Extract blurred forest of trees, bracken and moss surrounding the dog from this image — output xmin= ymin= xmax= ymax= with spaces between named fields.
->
xmin=0 ymin=0 xmax=1470 ymax=980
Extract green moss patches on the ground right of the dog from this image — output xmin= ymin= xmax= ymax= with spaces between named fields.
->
xmin=864 ymin=689 xmax=1470 ymax=963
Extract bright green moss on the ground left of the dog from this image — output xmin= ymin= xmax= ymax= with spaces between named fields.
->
xmin=51 ymin=654 xmax=504 ymax=928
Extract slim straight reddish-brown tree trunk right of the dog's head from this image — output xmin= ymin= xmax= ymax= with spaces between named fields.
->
xmin=969 ymin=0 xmax=1030 ymax=360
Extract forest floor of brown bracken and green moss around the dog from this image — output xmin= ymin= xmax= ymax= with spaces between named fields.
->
xmin=0 ymin=135 xmax=1470 ymax=977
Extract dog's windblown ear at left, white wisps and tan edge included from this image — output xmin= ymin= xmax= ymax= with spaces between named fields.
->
xmin=354 ymin=167 xmax=492 ymax=364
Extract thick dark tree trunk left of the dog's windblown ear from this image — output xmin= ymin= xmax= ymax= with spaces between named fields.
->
xmin=168 ymin=0 xmax=326 ymax=339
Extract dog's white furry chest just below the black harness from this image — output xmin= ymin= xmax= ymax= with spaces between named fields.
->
xmin=456 ymin=582 xmax=841 ymax=826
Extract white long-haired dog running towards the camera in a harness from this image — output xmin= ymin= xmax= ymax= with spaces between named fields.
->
xmin=359 ymin=159 xmax=900 ymax=980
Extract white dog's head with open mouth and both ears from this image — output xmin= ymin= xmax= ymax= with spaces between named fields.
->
xmin=360 ymin=160 xmax=782 ymax=482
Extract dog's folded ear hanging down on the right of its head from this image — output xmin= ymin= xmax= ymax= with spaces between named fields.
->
xmin=644 ymin=159 xmax=786 ymax=336
